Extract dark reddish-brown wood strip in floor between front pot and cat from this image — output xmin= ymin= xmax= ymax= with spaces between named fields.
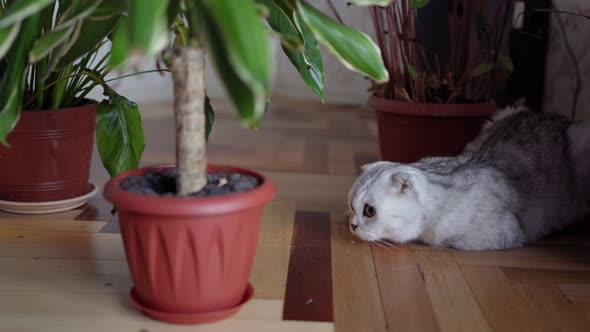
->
xmin=283 ymin=211 xmax=334 ymax=322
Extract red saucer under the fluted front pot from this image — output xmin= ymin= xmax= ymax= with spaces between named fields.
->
xmin=129 ymin=283 xmax=254 ymax=324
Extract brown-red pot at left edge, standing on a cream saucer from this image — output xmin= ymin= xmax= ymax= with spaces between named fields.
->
xmin=0 ymin=104 xmax=96 ymax=202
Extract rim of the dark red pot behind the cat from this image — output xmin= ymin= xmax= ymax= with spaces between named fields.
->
xmin=368 ymin=95 xmax=497 ymax=117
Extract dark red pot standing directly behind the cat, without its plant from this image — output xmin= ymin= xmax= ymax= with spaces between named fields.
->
xmin=369 ymin=96 xmax=496 ymax=163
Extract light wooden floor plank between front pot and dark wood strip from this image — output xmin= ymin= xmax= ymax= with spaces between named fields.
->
xmin=250 ymin=202 xmax=295 ymax=300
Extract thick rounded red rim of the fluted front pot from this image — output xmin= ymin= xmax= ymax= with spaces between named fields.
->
xmin=103 ymin=164 xmax=276 ymax=216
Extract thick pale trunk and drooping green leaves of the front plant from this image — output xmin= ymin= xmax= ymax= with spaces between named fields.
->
xmin=111 ymin=0 xmax=389 ymax=194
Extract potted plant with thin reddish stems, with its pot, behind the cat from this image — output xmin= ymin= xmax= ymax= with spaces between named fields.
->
xmin=369 ymin=0 xmax=514 ymax=162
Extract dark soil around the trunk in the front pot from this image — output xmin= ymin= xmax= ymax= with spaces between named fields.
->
xmin=120 ymin=169 xmax=260 ymax=197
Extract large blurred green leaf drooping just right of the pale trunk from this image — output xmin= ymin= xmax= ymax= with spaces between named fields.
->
xmin=202 ymin=0 xmax=271 ymax=97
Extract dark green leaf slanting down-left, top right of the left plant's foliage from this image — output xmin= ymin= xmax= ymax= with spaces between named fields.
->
xmin=56 ymin=0 xmax=125 ymax=69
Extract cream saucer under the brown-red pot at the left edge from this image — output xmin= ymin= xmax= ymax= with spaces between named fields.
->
xmin=0 ymin=182 xmax=98 ymax=214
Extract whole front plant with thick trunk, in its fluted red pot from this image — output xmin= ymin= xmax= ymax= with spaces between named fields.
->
xmin=104 ymin=0 xmax=388 ymax=323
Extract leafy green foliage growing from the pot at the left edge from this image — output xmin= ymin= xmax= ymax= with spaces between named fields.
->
xmin=0 ymin=0 xmax=144 ymax=175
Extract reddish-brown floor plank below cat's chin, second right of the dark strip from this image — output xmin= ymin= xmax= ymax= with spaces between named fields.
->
xmin=373 ymin=246 xmax=439 ymax=332
